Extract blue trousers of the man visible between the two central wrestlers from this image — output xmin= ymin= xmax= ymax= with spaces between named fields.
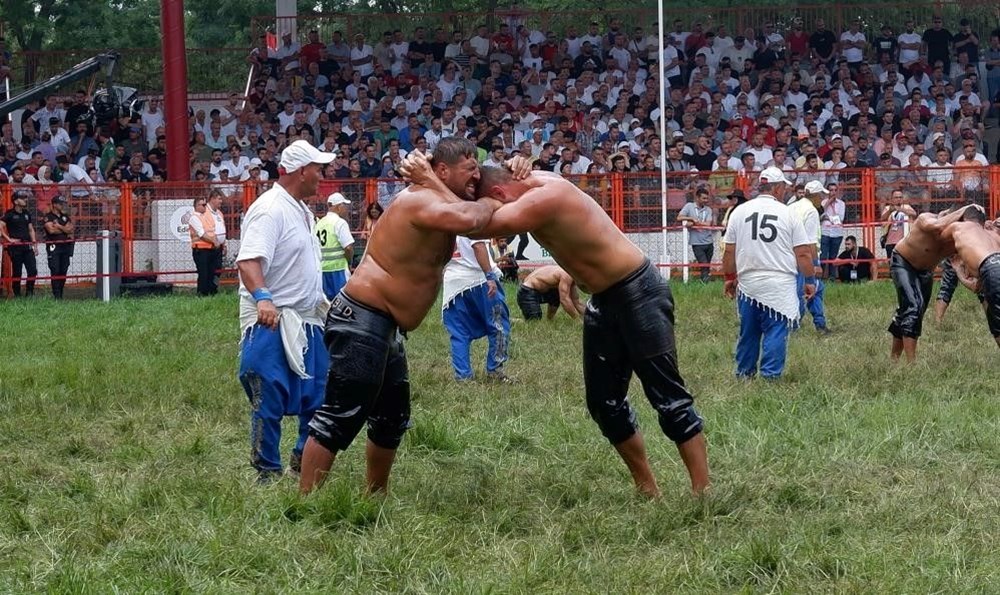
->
xmin=443 ymin=283 xmax=510 ymax=380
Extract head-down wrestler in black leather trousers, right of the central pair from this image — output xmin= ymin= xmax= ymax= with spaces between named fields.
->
xmin=404 ymin=158 xmax=709 ymax=497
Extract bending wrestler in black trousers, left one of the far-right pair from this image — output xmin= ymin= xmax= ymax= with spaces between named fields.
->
xmin=889 ymin=205 xmax=986 ymax=362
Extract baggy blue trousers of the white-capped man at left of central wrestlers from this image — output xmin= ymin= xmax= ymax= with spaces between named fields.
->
xmin=239 ymin=325 xmax=330 ymax=472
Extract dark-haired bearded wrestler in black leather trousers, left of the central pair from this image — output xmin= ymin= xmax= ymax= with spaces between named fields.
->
xmin=299 ymin=137 xmax=526 ymax=493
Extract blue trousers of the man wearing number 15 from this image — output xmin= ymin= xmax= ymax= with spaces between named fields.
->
xmin=736 ymin=294 xmax=789 ymax=378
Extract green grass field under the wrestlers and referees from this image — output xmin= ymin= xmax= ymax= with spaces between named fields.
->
xmin=0 ymin=283 xmax=1000 ymax=593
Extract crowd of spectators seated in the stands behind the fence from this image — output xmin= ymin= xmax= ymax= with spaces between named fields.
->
xmin=0 ymin=18 xmax=1000 ymax=226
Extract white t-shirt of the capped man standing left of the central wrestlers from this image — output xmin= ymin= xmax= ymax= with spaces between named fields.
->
xmin=236 ymin=184 xmax=324 ymax=312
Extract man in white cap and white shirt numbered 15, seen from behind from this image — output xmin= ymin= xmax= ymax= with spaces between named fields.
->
xmin=722 ymin=167 xmax=816 ymax=379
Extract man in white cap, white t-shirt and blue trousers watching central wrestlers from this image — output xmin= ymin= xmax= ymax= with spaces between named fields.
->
xmin=236 ymin=140 xmax=335 ymax=483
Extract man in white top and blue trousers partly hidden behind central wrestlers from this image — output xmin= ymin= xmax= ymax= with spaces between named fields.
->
xmin=441 ymin=236 xmax=511 ymax=383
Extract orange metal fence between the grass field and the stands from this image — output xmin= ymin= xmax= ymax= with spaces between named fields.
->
xmin=0 ymin=165 xmax=1000 ymax=295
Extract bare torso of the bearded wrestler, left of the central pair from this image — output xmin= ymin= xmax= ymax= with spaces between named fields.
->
xmin=344 ymin=187 xmax=455 ymax=331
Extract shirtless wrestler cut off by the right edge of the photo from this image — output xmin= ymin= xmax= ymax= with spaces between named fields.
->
xmin=952 ymin=222 xmax=1000 ymax=347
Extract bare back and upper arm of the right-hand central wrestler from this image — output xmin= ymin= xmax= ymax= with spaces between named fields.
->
xmin=475 ymin=171 xmax=646 ymax=293
